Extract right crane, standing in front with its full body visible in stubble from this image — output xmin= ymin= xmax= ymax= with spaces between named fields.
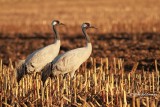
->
xmin=41 ymin=23 xmax=95 ymax=83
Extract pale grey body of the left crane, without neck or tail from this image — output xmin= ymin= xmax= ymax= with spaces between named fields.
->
xmin=25 ymin=40 xmax=60 ymax=73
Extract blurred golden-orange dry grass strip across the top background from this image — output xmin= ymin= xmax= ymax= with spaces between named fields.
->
xmin=0 ymin=0 xmax=160 ymax=34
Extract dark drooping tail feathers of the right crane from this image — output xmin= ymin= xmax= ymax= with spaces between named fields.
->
xmin=41 ymin=63 xmax=52 ymax=86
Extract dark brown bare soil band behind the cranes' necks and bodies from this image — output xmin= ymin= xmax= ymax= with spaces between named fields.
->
xmin=0 ymin=33 xmax=160 ymax=71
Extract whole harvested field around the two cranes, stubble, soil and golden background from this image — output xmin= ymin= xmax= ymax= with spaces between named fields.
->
xmin=0 ymin=0 xmax=160 ymax=107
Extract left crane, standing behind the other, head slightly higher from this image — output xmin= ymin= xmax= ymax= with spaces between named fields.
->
xmin=17 ymin=20 xmax=64 ymax=82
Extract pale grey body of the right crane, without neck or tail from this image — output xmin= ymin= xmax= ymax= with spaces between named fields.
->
xmin=52 ymin=43 xmax=92 ymax=77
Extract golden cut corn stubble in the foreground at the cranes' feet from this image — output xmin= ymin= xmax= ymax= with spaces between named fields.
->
xmin=0 ymin=58 xmax=160 ymax=107
